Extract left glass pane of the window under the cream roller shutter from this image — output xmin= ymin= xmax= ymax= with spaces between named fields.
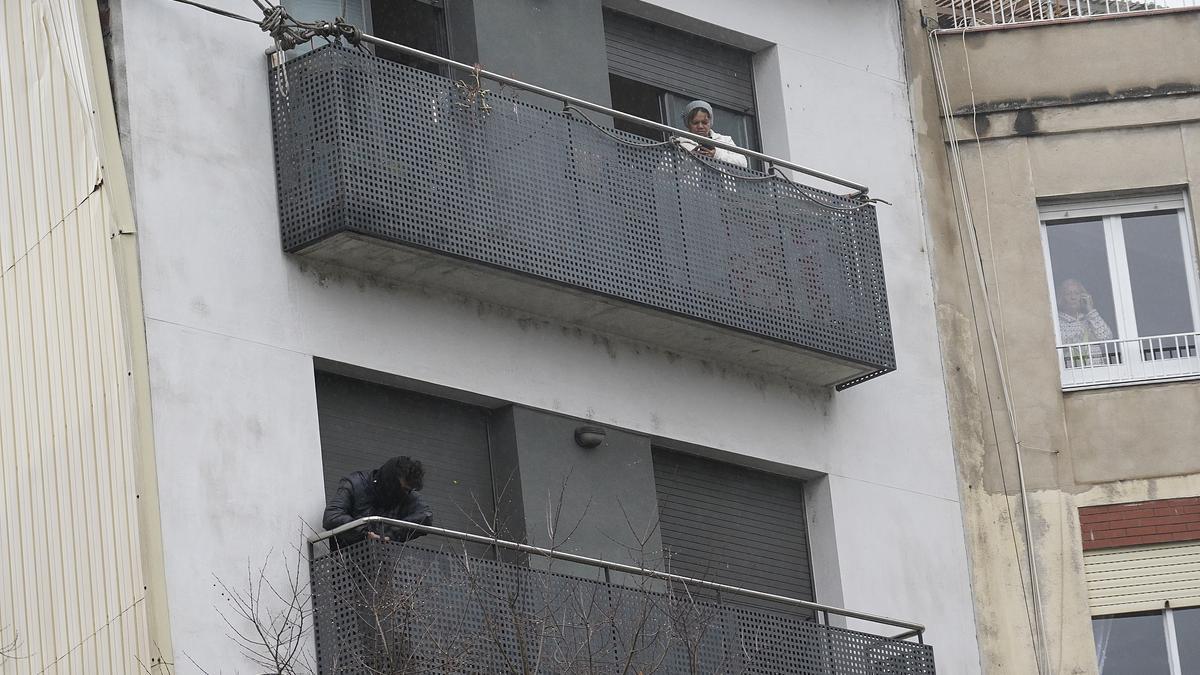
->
xmin=1092 ymin=611 xmax=1170 ymax=675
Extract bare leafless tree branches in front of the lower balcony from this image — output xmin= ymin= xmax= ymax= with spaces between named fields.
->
xmin=225 ymin=474 xmax=757 ymax=675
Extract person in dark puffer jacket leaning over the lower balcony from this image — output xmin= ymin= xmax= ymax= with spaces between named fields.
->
xmin=322 ymin=455 xmax=433 ymax=546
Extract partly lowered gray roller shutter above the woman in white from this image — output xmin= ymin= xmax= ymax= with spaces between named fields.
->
xmin=604 ymin=11 xmax=755 ymax=114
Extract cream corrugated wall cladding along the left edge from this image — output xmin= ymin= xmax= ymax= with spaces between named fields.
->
xmin=0 ymin=0 xmax=151 ymax=675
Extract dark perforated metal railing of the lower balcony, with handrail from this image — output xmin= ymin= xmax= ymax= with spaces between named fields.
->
xmin=310 ymin=518 xmax=934 ymax=675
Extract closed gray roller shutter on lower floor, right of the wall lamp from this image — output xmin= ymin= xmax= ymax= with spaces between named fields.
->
xmin=654 ymin=449 xmax=812 ymax=609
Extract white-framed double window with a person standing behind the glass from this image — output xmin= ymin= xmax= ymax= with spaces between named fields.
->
xmin=1042 ymin=195 xmax=1200 ymax=388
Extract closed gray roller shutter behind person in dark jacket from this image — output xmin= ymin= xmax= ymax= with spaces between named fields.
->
xmin=317 ymin=372 xmax=494 ymax=532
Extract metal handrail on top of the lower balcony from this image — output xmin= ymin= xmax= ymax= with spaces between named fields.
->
xmin=308 ymin=515 xmax=925 ymax=644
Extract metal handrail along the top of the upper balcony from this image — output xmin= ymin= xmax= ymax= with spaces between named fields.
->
xmin=324 ymin=32 xmax=870 ymax=197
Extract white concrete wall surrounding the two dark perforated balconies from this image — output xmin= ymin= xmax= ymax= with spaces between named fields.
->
xmin=112 ymin=0 xmax=978 ymax=673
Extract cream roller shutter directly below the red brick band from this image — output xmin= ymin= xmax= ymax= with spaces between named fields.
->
xmin=1084 ymin=542 xmax=1200 ymax=616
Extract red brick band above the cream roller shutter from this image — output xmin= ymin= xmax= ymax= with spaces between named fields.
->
xmin=1079 ymin=497 xmax=1200 ymax=550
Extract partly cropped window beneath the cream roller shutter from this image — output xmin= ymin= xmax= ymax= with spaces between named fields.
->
xmin=1092 ymin=607 xmax=1200 ymax=675
